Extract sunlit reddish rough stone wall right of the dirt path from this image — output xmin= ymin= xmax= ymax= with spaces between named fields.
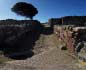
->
xmin=54 ymin=26 xmax=86 ymax=53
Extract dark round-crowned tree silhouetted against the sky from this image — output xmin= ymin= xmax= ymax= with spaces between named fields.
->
xmin=11 ymin=2 xmax=38 ymax=20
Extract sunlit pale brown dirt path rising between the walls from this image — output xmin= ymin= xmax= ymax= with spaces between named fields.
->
xmin=0 ymin=35 xmax=84 ymax=70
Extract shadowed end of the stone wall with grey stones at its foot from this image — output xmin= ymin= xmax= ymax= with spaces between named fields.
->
xmin=75 ymin=29 xmax=86 ymax=64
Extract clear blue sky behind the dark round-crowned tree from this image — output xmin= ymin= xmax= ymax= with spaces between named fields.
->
xmin=0 ymin=0 xmax=86 ymax=22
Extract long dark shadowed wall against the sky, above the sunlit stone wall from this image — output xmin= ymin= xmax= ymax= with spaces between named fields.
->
xmin=49 ymin=16 xmax=86 ymax=26
